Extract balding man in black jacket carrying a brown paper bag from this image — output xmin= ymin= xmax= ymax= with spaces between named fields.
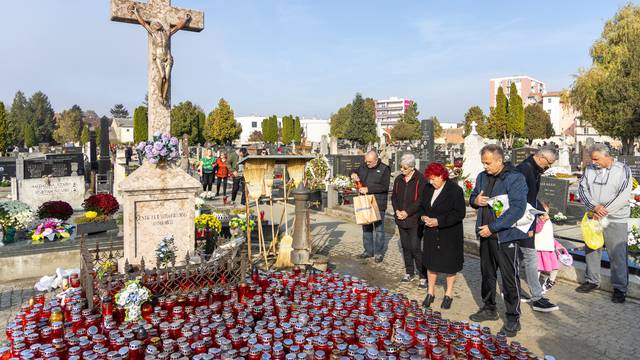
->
xmin=351 ymin=150 xmax=391 ymax=263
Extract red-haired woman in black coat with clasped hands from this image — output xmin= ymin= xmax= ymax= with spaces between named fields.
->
xmin=421 ymin=163 xmax=466 ymax=309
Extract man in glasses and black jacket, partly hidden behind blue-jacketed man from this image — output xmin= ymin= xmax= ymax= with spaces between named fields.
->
xmin=516 ymin=147 xmax=558 ymax=312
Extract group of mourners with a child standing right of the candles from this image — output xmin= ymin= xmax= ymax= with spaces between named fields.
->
xmin=351 ymin=144 xmax=632 ymax=336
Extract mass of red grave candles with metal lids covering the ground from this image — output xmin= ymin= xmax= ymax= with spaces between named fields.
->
xmin=0 ymin=268 xmax=536 ymax=360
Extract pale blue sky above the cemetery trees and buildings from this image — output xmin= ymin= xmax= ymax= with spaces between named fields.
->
xmin=0 ymin=0 xmax=625 ymax=122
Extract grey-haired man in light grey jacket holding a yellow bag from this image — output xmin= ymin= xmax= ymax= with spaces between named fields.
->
xmin=576 ymin=143 xmax=633 ymax=303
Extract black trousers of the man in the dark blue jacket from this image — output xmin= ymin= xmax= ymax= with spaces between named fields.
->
xmin=480 ymin=238 xmax=520 ymax=321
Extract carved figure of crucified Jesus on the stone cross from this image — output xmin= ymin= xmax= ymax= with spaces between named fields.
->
xmin=129 ymin=4 xmax=191 ymax=106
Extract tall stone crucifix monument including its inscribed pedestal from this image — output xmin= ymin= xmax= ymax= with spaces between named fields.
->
xmin=111 ymin=0 xmax=204 ymax=264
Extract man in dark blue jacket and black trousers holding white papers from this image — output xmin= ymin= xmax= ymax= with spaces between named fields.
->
xmin=469 ymin=144 xmax=527 ymax=336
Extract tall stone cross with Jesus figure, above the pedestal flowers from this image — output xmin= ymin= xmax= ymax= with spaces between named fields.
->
xmin=111 ymin=0 xmax=204 ymax=138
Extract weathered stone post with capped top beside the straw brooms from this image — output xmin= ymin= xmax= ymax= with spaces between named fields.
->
xmin=291 ymin=184 xmax=311 ymax=265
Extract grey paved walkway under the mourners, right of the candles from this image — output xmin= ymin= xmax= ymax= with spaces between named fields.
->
xmin=311 ymin=208 xmax=640 ymax=359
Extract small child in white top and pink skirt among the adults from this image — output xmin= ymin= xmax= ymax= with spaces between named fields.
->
xmin=535 ymin=215 xmax=560 ymax=294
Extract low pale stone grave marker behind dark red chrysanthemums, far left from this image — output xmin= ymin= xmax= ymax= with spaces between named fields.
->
xmin=11 ymin=176 xmax=85 ymax=210
